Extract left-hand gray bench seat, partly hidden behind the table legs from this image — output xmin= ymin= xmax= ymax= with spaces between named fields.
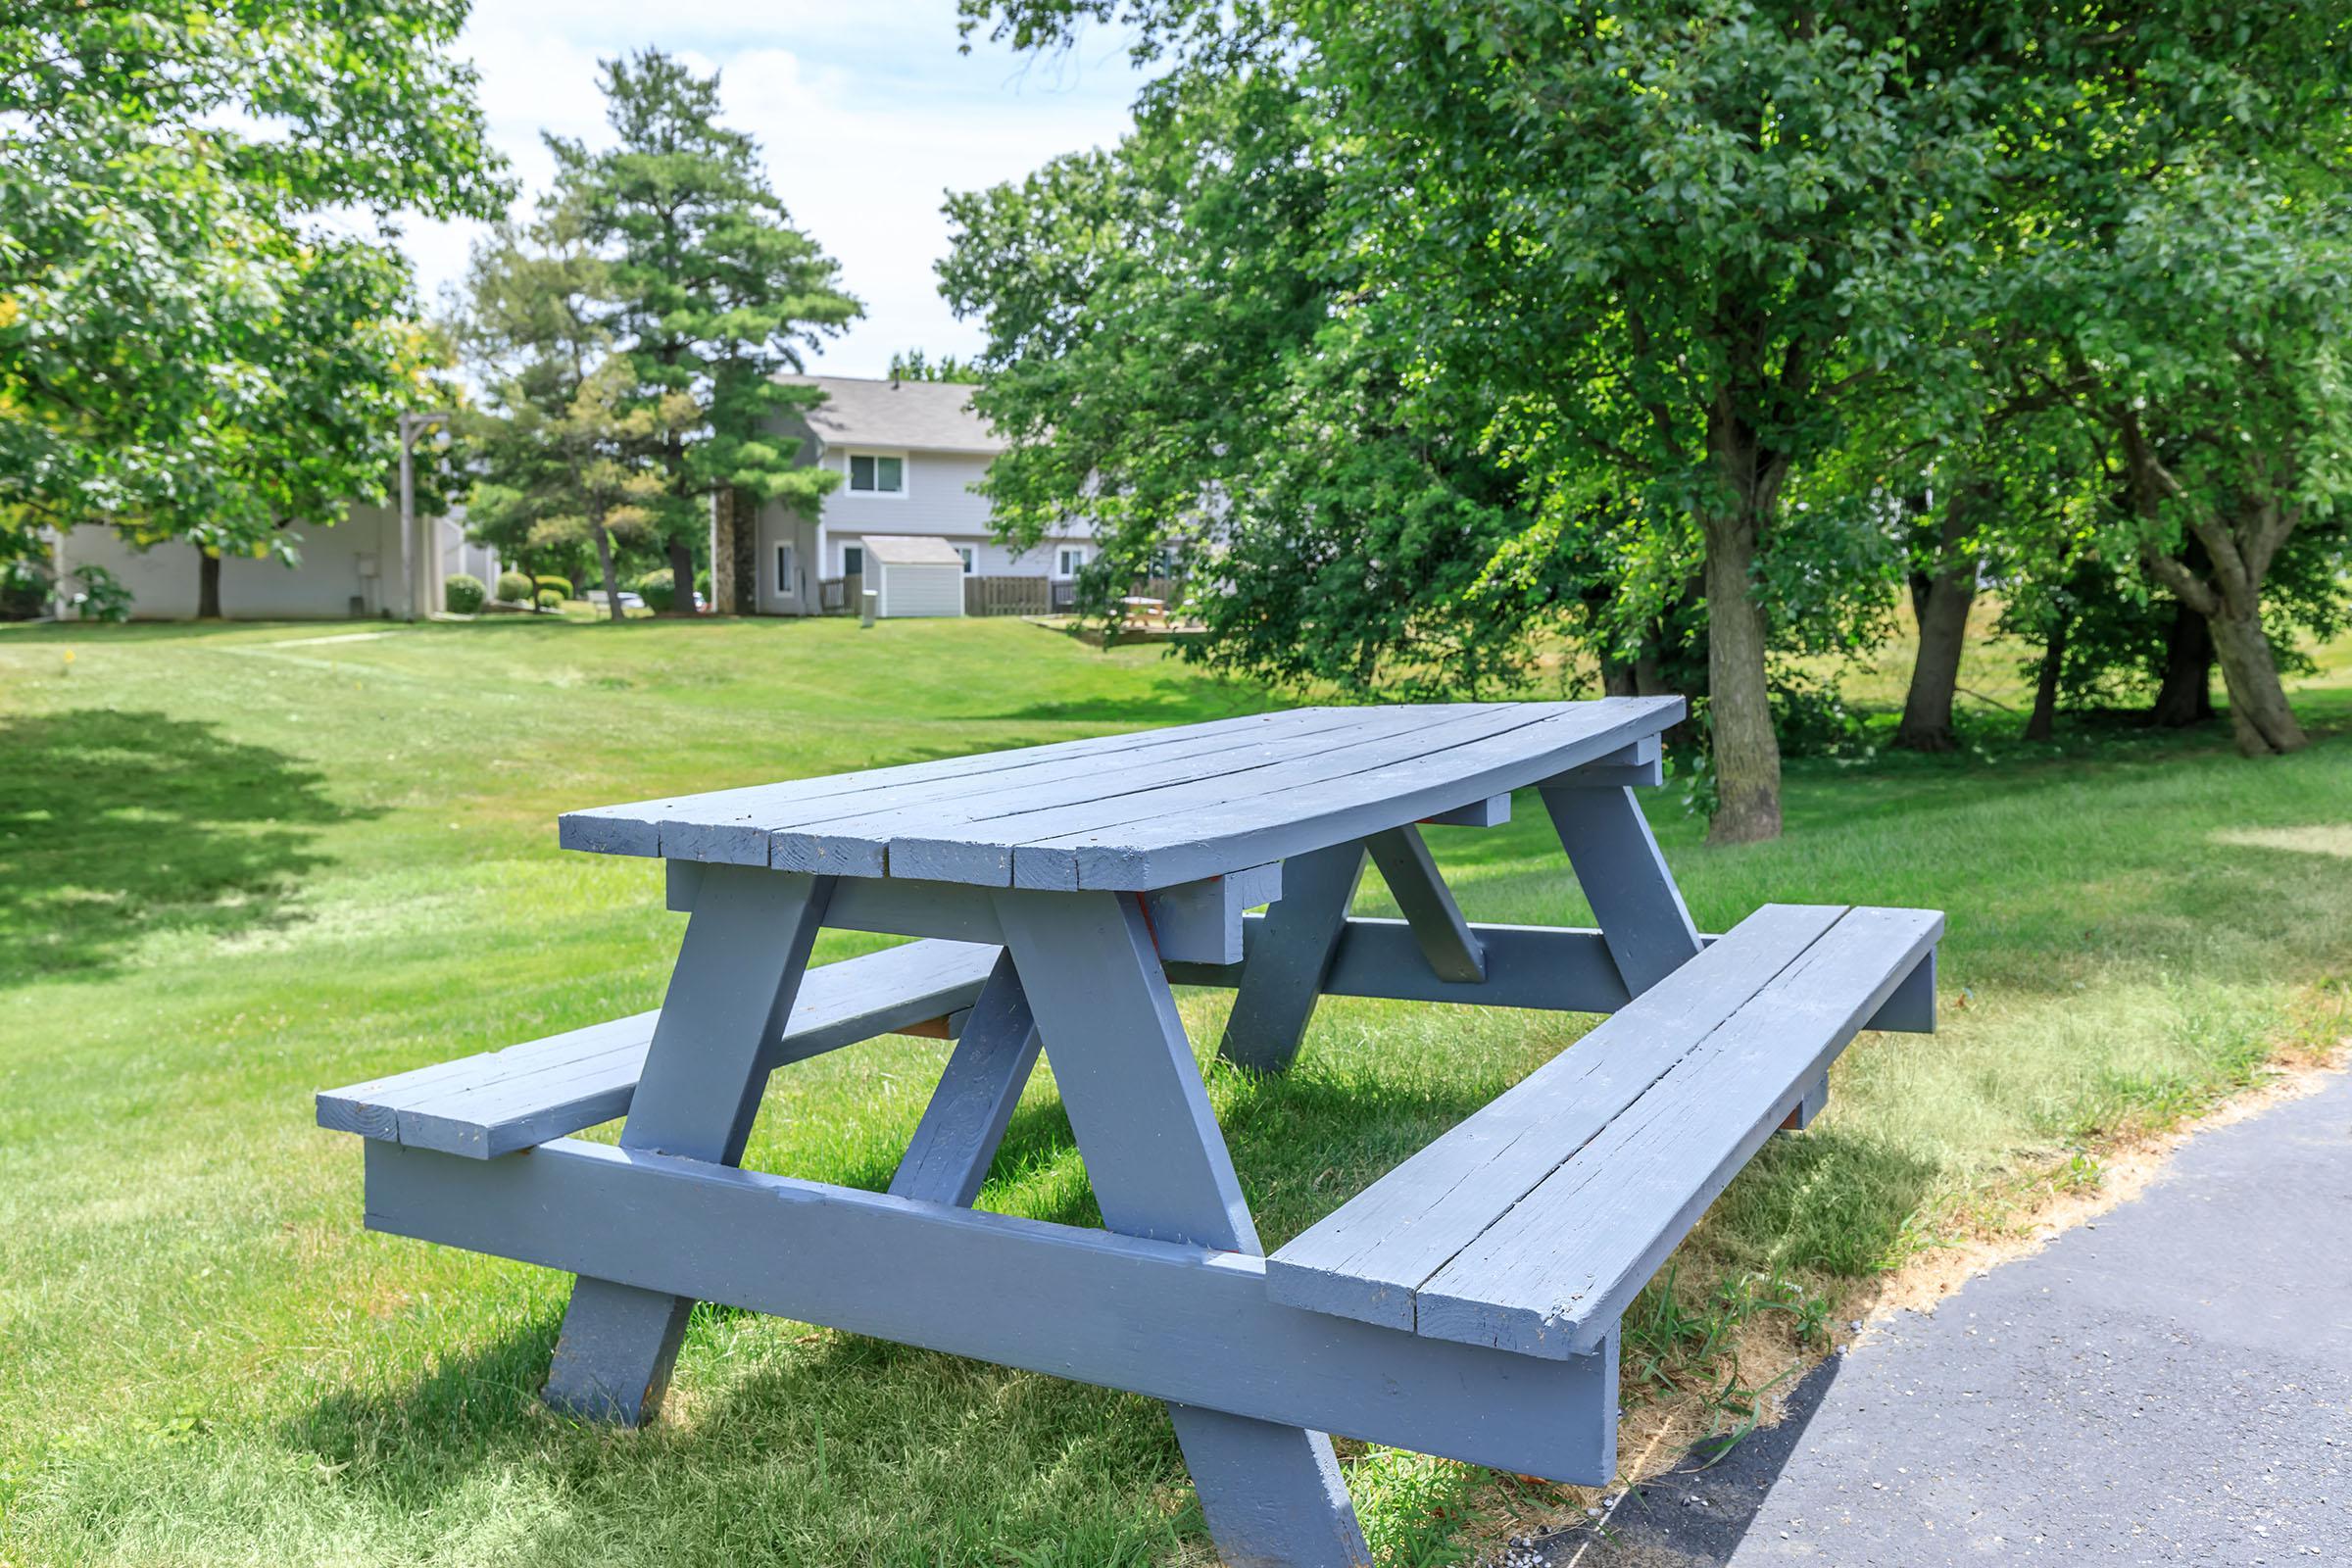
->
xmin=318 ymin=938 xmax=1000 ymax=1159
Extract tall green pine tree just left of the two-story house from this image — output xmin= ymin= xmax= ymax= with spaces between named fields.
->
xmin=548 ymin=49 xmax=858 ymax=613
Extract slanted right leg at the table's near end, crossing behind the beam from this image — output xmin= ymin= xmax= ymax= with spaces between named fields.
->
xmin=998 ymin=893 xmax=1371 ymax=1568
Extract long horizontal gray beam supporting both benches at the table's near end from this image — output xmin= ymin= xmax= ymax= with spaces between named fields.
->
xmin=367 ymin=1138 xmax=1616 ymax=1486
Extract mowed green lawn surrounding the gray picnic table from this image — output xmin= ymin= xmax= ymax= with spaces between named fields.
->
xmin=0 ymin=620 xmax=2352 ymax=1568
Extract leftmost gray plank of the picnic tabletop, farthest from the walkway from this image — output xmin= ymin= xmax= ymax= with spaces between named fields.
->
xmin=560 ymin=708 xmax=1364 ymax=860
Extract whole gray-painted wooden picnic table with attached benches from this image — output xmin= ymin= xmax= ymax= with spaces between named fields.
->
xmin=318 ymin=698 xmax=1942 ymax=1568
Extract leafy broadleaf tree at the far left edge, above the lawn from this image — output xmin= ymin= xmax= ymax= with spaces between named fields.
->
xmin=0 ymin=0 xmax=506 ymax=606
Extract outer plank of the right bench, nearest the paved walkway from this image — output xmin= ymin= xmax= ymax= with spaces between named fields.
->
xmin=1416 ymin=909 xmax=1942 ymax=1356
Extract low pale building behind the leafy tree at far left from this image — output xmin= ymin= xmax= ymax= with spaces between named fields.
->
xmin=52 ymin=503 xmax=499 ymax=620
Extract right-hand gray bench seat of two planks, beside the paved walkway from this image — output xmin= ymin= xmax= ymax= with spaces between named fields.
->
xmin=1265 ymin=906 xmax=1942 ymax=1359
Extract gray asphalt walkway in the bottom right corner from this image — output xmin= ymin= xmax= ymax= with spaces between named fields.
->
xmin=1541 ymin=1077 xmax=2352 ymax=1568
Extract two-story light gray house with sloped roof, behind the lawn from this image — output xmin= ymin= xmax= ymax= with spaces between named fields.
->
xmin=710 ymin=376 xmax=1094 ymax=615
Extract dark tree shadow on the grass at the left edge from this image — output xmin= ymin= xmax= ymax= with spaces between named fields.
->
xmin=0 ymin=708 xmax=365 ymax=980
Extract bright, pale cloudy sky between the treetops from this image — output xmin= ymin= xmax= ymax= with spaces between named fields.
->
xmin=402 ymin=0 xmax=1136 ymax=376
